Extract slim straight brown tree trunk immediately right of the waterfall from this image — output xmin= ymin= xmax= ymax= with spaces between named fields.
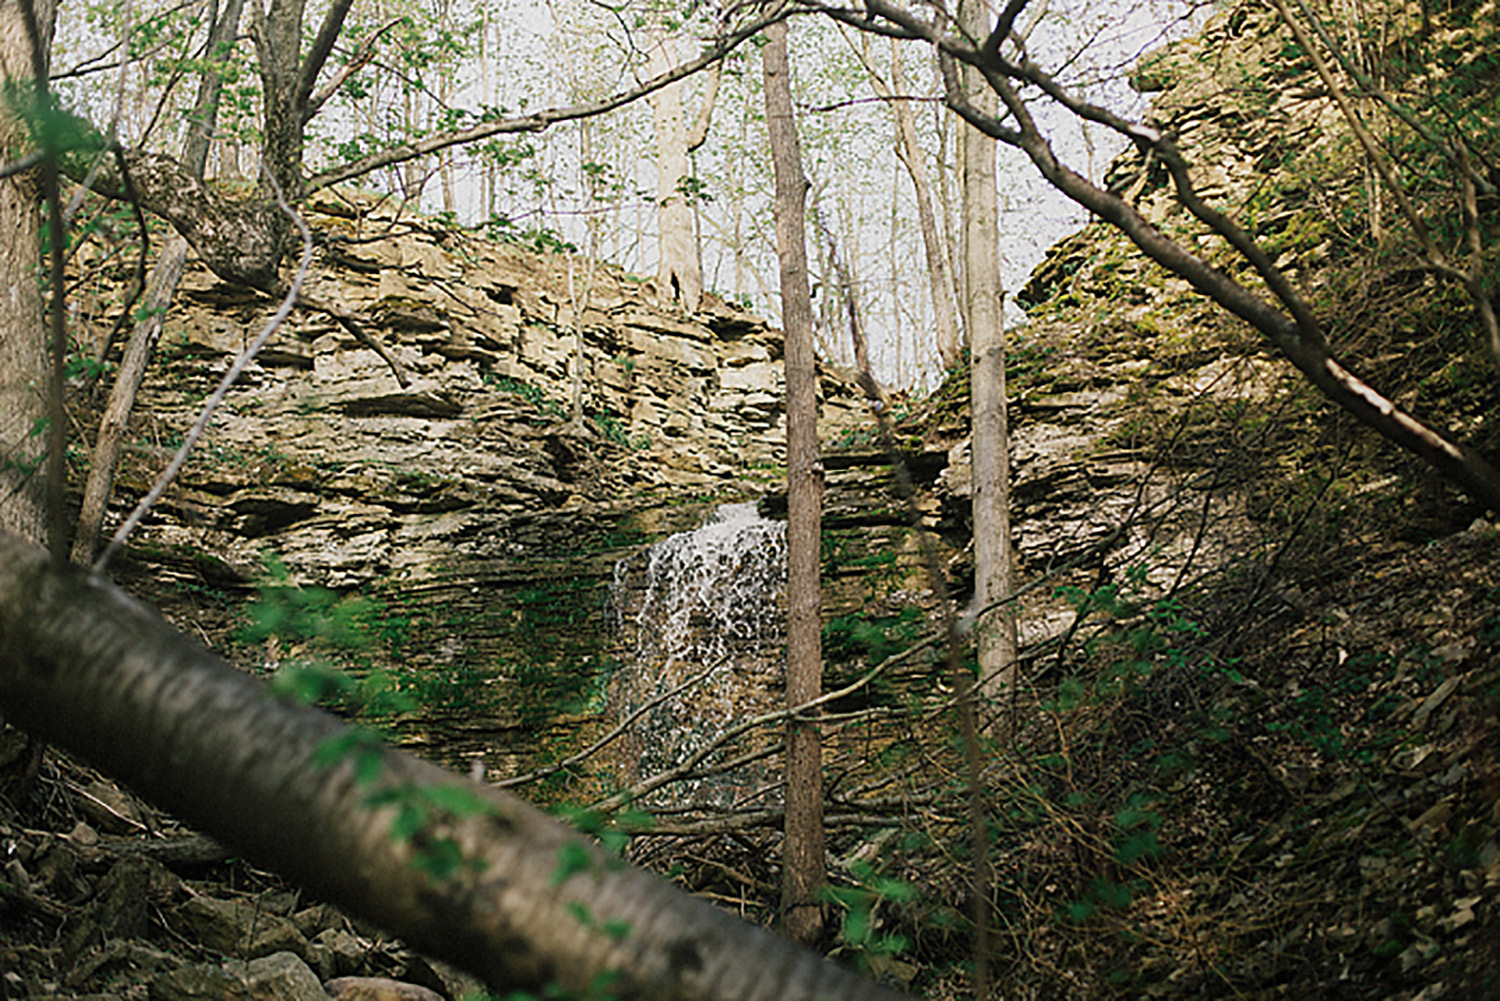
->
xmin=761 ymin=23 xmax=825 ymax=942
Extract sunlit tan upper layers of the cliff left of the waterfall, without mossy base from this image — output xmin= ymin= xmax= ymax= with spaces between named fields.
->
xmin=108 ymin=189 xmax=870 ymax=587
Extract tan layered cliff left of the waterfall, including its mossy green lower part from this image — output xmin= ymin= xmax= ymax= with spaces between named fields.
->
xmin=90 ymin=197 xmax=861 ymax=771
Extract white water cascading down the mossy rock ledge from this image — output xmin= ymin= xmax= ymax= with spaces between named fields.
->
xmin=611 ymin=504 xmax=786 ymax=806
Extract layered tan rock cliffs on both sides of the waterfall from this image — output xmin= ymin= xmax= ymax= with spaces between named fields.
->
xmin=90 ymin=0 xmax=1484 ymax=792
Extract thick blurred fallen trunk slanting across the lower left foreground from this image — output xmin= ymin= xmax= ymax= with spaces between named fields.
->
xmin=0 ymin=534 xmax=899 ymax=1001
